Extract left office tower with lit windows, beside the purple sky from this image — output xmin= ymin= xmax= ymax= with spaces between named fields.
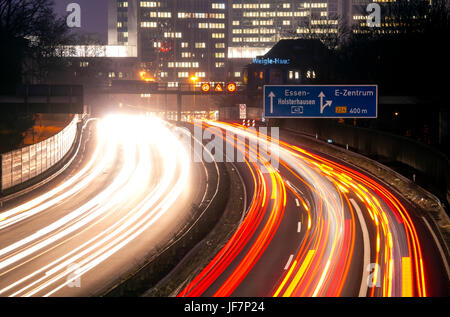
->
xmin=109 ymin=0 xmax=228 ymax=86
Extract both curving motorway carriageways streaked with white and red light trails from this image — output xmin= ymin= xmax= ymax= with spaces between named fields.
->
xmin=0 ymin=115 xmax=448 ymax=297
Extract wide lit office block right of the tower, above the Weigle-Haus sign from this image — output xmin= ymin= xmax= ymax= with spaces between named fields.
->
xmin=228 ymin=0 xmax=342 ymax=58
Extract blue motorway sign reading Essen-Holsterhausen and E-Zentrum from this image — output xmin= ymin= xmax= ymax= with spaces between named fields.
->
xmin=264 ymin=85 xmax=378 ymax=118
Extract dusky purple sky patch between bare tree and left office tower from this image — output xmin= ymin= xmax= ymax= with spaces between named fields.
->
xmin=54 ymin=0 xmax=108 ymax=41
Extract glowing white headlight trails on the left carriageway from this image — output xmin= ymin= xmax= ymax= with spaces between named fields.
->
xmin=0 ymin=116 xmax=190 ymax=296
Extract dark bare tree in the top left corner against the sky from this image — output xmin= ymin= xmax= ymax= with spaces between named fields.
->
xmin=0 ymin=0 xmax=70 ymax=90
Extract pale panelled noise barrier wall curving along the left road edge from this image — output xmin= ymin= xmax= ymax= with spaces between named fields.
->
xmin=1 ymin=115 xmax=78 ymax=192
